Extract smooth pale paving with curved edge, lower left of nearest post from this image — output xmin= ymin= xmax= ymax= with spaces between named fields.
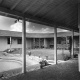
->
xmin=0 ymin=60 xmax=22 ymax=72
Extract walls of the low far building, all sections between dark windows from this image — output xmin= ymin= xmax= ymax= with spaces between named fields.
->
xmin=0 ymin=37 xmax=79 ymax=51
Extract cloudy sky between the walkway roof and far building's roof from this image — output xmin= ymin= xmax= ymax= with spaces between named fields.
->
xmin=0 ymin=16 xmax=67 ymax=33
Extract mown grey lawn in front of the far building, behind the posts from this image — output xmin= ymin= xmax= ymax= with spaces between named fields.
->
xmin=12 ymin=49 xmax=70 ymax=60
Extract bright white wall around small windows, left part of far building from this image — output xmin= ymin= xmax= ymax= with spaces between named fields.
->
xmin=0 ymin=37 xmax=32 ymax=51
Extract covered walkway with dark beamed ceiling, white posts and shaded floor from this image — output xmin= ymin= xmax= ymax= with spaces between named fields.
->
xmin=0 ymin=0 xmax=80 ymax=80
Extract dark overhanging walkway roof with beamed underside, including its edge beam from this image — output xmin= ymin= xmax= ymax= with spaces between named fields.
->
xmin=0 ymin=0 xmax=78 ymax=31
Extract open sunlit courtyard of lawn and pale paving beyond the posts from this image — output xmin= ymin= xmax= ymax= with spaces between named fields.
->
xmin=0 ymin=49 xmax=70 ymax=77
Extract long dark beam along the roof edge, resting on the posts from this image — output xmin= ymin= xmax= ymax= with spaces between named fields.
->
xmin=0 ymin=7 xmax=78 ymax=31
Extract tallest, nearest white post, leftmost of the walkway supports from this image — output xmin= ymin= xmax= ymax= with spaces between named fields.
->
xmin=22 ymin=17 xmax=26 ymax=73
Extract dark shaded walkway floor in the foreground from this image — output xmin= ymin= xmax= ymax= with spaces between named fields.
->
xmin=1 ymin=59 xmax=80 ymax=80
